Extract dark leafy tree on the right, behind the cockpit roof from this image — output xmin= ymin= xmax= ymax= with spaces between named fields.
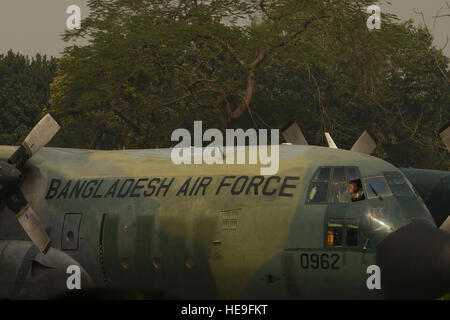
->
xmin=252 ymin=22 xmax=450 ymax=169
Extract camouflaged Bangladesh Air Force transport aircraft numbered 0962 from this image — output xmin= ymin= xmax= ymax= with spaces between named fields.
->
xmin=0 ymin=115 xmax=450 ymax=299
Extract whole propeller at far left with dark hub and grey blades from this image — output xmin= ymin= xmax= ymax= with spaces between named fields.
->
xmin=0 ymin=114 xmax=60 ymax=253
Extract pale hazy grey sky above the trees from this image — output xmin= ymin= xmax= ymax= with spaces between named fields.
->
xmin=0 ymin=0 xmax=450 ymax=57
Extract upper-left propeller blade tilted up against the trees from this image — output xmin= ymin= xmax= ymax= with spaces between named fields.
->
xmin=8 ymin=114 xmax=61 ymax=169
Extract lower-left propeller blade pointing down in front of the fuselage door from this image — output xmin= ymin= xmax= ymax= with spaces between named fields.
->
xmin=6 ymin=188 xmax=50 ymax=254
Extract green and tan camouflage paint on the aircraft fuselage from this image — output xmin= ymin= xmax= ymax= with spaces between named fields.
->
xmin=0 ymin=146 xmax=440 ymax=299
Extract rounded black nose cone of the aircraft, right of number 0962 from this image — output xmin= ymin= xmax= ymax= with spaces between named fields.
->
xmin=377 ymin=222 xmax=450 ymax=299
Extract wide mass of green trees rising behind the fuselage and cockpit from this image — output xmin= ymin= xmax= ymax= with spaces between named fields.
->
xmin=46 ymin=0 xmax=450 ymax=169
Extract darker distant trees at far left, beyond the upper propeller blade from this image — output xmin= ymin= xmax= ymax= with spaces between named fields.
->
xmin=0 ymin=51 xmax=56 ymax=145
